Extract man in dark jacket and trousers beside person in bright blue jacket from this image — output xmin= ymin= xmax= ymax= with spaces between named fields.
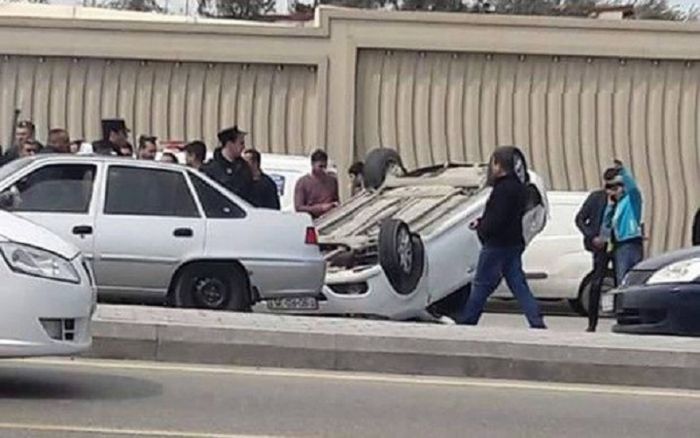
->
xmin=576 ymin=168 xmax=619 ymax=332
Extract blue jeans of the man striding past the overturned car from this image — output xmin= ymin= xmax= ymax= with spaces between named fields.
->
xmin=456 ymin=246 xmax=546 ymax=328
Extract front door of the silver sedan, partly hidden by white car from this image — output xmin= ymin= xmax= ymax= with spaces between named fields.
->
xmin=3 ymin=163 xmax=101 ymax=259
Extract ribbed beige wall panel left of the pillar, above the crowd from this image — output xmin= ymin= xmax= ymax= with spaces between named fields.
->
xmin=0 ymin=56 xmax=320 ymax=154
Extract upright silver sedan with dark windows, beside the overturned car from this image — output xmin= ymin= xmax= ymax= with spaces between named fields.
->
xmin=0 ymin=154 xmax=325 ymax=310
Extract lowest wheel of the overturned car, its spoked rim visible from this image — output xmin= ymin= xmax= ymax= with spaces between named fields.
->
xmin=379 ymin=219 xmax=425 ymax=295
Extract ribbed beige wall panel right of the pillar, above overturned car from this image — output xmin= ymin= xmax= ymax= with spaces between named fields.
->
xmin=355 ymin=49 xmax=700 ymax=253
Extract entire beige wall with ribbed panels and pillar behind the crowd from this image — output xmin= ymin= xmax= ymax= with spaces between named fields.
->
xmin=0 ymin=5 xmax=700 ymax=252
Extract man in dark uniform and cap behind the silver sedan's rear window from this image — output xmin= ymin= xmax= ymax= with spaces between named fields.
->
xmin=200 ymin=126 xmax=255 ymax=205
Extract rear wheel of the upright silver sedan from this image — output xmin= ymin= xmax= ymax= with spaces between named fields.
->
xmin=173 ymin=263 xmax=250 ymax=312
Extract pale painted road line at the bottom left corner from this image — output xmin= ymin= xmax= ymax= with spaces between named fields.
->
xmin=0 ymin=423 xmax=281 ymax=438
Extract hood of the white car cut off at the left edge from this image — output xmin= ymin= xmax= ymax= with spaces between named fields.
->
xmin=0 ymin=210 xmax=80 ymax=260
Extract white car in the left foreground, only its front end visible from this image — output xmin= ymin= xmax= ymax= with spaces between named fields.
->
xmin=0 ymin=211 xmax=96 ymax=358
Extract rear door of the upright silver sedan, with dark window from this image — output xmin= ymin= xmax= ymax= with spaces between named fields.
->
xmin=95 ymin=164 xmax=205 ymax=297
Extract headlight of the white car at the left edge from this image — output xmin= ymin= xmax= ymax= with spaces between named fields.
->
xmin=0 ymin=242 xmax=80 ymax=284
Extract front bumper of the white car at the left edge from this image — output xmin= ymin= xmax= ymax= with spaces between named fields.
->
xmin=0 ymin=261 xmax=96 ymax=357
